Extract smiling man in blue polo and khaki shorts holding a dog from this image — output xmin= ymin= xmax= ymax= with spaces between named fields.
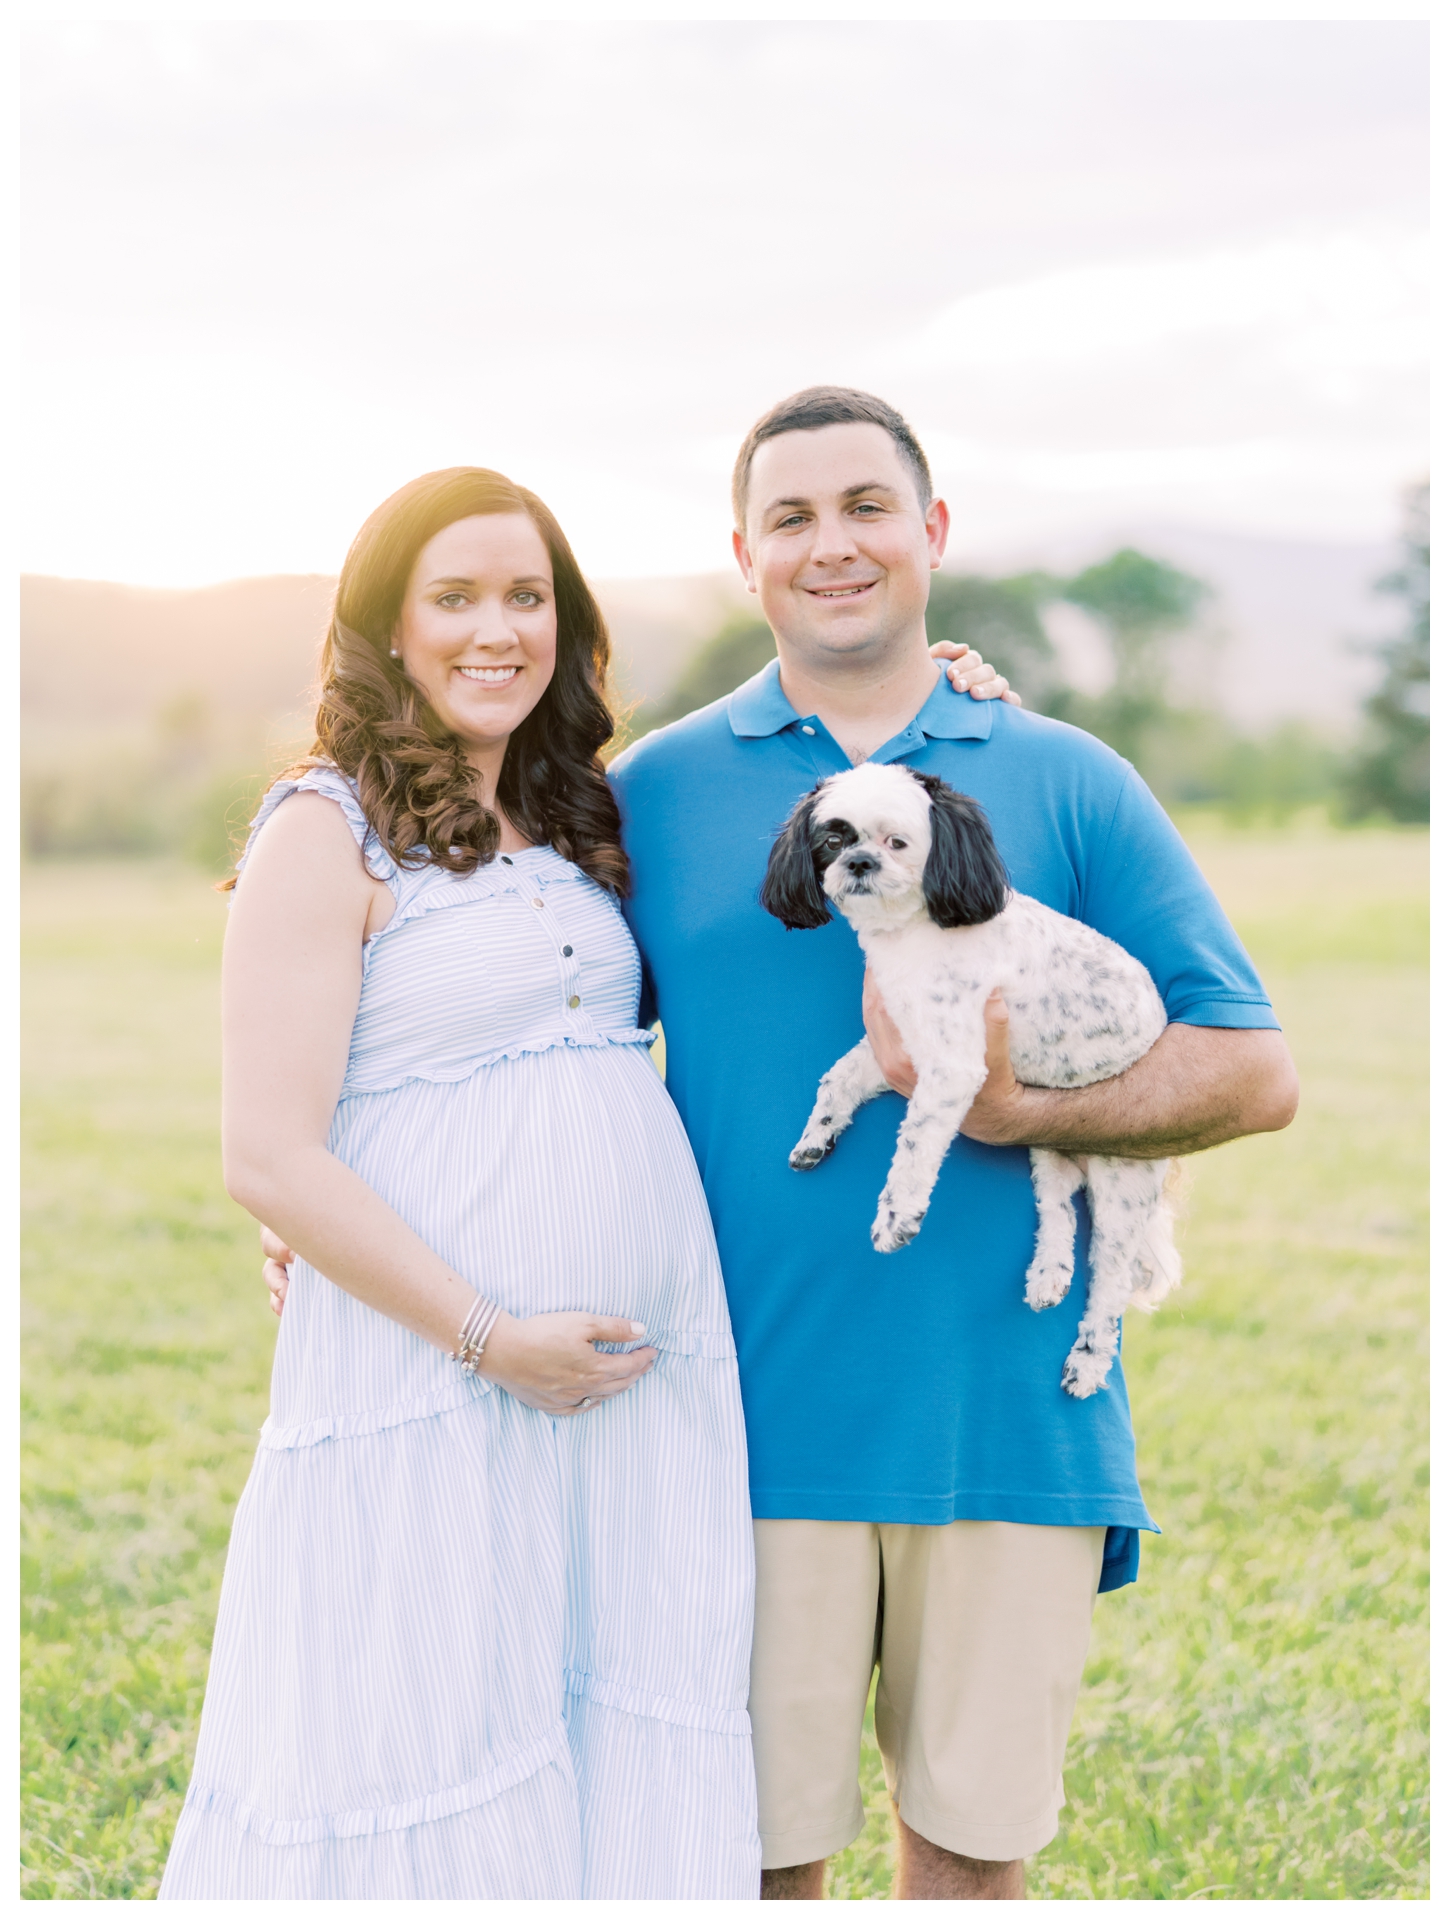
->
xmin=271 ymin=388 xmax=1296 ymax=1899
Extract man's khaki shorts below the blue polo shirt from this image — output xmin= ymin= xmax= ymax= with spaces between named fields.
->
xmin=751 ymin=1521 xmax=1104 ymax=1866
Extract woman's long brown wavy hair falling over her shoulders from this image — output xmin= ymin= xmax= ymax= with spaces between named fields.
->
xmin=232 ymin=467 xmax=630 ymax=895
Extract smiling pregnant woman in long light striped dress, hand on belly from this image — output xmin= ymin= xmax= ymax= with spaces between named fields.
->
xmin=161 ymin=468 xmax=759 ymax=1899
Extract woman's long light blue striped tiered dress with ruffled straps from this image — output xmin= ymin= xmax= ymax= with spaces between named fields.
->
xmin=161 ymin=768 xmax=759 ymax=1899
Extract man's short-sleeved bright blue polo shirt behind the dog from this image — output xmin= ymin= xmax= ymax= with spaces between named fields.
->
xmin=613 ymin=660 xmax=1277 ymax=1590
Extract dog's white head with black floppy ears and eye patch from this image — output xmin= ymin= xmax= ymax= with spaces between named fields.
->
xmin=761 ymin=760 xmax=1008 ymax=933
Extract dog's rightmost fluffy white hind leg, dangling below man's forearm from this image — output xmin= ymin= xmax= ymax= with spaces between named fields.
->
xmin=1062 ymin=1154 xmax=1181 ymax=1400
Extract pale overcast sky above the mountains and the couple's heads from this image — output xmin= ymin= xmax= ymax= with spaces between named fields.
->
xmin=21 ymin=23 xmax=1429 ymax=586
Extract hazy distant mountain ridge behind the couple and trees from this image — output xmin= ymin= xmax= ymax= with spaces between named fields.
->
xmin=21 ymin=526 xmax=1394 ymax=735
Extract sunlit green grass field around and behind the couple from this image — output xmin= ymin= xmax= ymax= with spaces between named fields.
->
xmin=21 ymin=822 xmax=1429 ymax=1899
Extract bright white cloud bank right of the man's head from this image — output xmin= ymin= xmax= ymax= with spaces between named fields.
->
xmin=880 ymin=227 xmax=1431 ymax=545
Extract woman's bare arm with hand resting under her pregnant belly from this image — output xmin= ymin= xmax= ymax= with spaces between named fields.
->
xmin=223 ymin=793 xmax=655 ymax=1413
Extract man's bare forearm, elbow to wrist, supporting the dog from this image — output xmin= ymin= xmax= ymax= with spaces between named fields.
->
xmin=962 ymin=1025 xmax=1298 ymax=1160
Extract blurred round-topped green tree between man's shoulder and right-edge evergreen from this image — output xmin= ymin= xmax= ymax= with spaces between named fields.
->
xmin=1054 ymin=547 xmax=1212 ymax=766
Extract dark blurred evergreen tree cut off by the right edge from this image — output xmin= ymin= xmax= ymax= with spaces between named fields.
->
xmin=1342 ymin=482 xmax=1431 ymax=820
